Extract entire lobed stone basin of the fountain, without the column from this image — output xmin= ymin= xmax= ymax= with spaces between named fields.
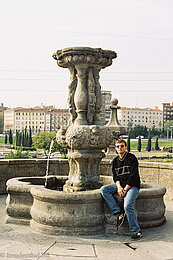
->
xmin=6 ymin=176 xmax=166 ymax=235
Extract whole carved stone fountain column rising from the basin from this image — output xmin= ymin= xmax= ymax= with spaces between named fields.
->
xmin=53 ymin=47 xmax=116 ymax=192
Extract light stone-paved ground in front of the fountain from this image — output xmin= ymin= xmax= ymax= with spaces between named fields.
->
xmin=0 ymin=195 xmax=173 ymax=260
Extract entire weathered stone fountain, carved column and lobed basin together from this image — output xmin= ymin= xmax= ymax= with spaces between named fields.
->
xmin=6 ymin=47 xmax=165 ymax=235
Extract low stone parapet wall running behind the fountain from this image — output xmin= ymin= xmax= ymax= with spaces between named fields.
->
xmin=0 ymin=159 xmax=173 ymax=200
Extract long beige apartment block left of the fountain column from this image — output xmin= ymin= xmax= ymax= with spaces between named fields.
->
xmin=4 ymin=106 xmax=70 ymax=133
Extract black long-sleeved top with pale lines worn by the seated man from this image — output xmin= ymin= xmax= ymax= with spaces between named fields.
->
xmin=112 ymin=152 xmax=140 ymax=189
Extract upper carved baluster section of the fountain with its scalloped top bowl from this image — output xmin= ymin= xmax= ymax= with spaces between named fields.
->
xmin=53 ymin=47 xmax=117 ymax=125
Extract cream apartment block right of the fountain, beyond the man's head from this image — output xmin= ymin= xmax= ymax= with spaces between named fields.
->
xmin=117 ymin=107 xmax=163 ymax=129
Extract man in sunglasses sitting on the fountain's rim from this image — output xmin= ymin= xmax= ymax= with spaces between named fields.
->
xmin=101 ymin=139 xmax=142 ymax=240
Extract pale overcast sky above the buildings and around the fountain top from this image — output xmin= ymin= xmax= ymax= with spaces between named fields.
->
xmin=0 ymin=0 xmax=173 ymax=108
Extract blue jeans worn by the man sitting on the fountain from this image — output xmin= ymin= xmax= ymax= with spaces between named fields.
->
xmin=101 ymin=184 xmax=140 ymax=234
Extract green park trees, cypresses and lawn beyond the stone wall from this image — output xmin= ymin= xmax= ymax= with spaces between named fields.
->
xmin=0 ymin=122 xmax=173 ymax=159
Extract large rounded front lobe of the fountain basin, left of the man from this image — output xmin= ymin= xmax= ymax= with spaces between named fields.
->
xmin=30 ymin=187 xmax=104 ymax=235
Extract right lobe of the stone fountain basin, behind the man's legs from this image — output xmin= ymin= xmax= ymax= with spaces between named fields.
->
xmin=101 ymin=176 xmax=166 ymax=234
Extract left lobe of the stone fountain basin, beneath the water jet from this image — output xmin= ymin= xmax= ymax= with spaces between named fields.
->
xmin=6 ymin=176 xmax=67 ymax=225
